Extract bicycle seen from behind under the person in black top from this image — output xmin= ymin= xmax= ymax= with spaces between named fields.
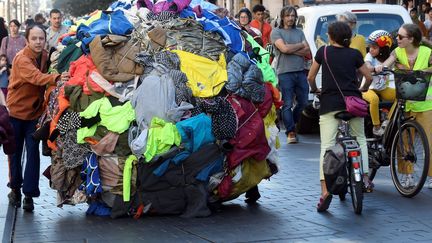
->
xmin=315 ymin=94 xmax=364 ymax=214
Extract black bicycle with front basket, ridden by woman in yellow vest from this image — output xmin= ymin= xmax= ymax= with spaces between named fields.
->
xmin=366 ymin=69 xmax=431 ymax=198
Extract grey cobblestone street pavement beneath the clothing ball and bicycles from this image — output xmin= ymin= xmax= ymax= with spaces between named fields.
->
xmin=0 ymin=135 xmax=432 ymax=243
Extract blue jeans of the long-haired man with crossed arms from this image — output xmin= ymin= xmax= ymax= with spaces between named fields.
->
xmin=278 ymin=71 xmax=309 ymax=134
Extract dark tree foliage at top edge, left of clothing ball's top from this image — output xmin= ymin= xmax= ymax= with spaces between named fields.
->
xmin=52 ymin=0 xmax=114 ymax=17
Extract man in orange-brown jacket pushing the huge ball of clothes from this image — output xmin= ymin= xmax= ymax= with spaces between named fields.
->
xmin=7 ymin=25 xmax=67 ymax=212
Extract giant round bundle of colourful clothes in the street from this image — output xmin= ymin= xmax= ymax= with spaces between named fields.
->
xmin=38 ymin=0 xmax=280 ymax=218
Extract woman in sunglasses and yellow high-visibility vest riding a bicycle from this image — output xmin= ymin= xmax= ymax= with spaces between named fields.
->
xmin=375 ymin=24 xmax=432 ymax=189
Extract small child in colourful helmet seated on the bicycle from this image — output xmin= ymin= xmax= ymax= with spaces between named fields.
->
xmin=362 ymin=30 xmax=396 ymax=136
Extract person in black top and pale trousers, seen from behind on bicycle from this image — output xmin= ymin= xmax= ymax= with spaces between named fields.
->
xmin=308 ymin=21 xmax=372 ymax=212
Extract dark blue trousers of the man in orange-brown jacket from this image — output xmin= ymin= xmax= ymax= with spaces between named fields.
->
xmin=9 ymin=117 xmax=40 ymax=197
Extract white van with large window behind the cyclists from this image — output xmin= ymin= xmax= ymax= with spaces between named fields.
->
xmin=297 ymin=3 xmax=412 ymax=133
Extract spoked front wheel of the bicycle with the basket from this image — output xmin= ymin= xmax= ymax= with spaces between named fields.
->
xmin=390 ymin=121 xmax=429 ymax=197
